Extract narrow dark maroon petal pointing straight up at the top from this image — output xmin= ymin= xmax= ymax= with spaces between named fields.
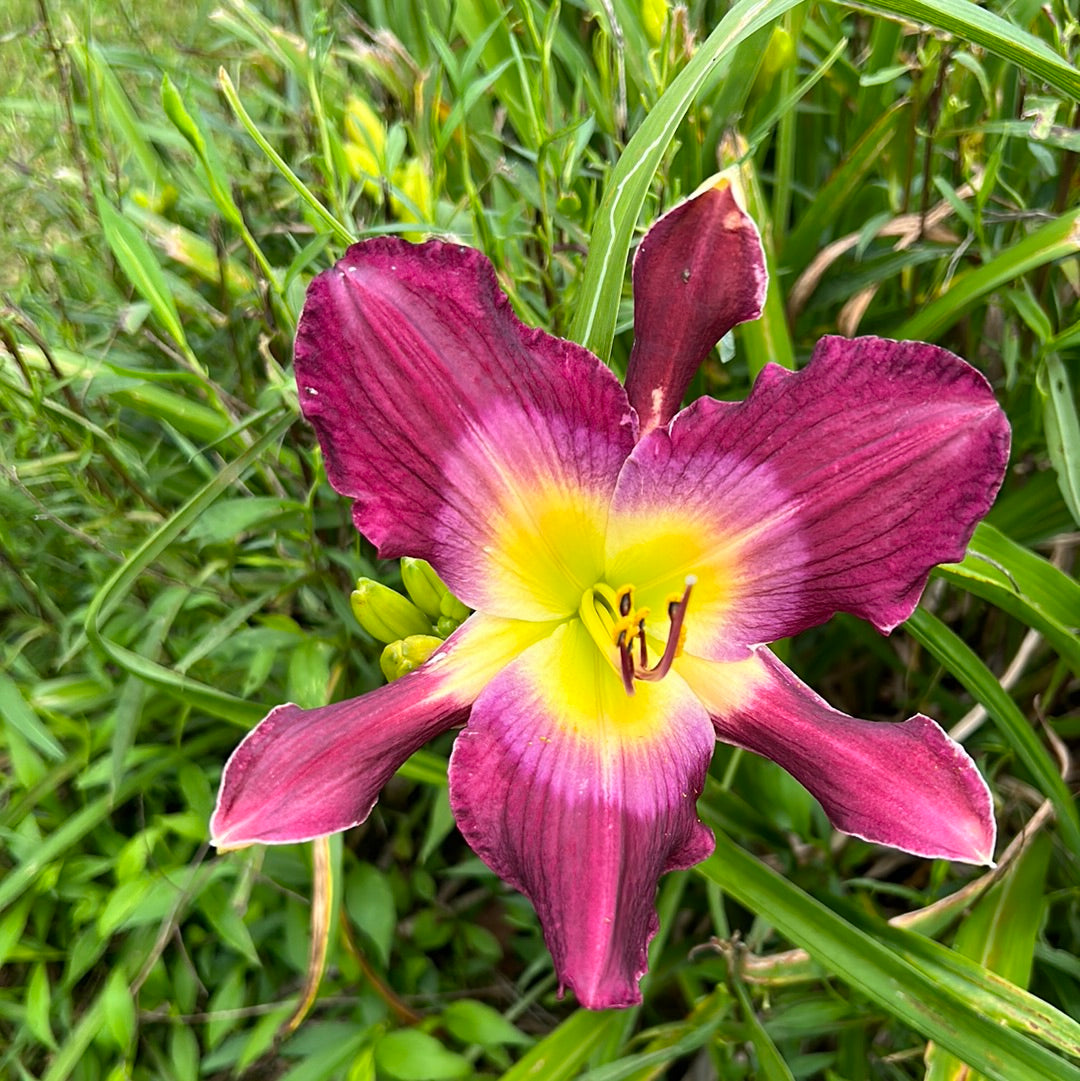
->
xmin=626 ymin=179 xmax=768 ymax=433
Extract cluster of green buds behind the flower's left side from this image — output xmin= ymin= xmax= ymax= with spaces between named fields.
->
xmin=349 ymin=557 xmax=469 ymax=681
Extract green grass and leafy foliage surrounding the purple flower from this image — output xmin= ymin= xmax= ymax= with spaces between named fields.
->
xmin=0 ymin=0 xmax=1080 ymax=1081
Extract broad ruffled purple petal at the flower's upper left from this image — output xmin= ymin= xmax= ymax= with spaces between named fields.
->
xmin=296 ymin=238 xmax=635 ymax=618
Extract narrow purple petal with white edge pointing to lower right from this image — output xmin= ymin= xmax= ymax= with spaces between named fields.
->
xmin=677 ymin=649 xmax=997 ymax=864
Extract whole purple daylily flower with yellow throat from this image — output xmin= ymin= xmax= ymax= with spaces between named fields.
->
xmin=212 ymin=184 xmax=1009 ymax=1007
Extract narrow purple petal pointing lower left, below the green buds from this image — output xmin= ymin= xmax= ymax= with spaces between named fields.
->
xmin=210 ymin=616 xmax=550 ymax=849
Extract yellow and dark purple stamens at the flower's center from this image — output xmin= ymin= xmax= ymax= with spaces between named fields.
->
xmin=578 ymin=575 xmax=697 ymax=694
